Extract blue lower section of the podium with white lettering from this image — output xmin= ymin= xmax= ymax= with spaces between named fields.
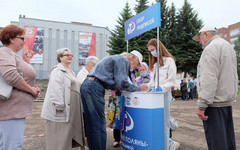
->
xmin=121 ymin=107 xmax=164 ymax=150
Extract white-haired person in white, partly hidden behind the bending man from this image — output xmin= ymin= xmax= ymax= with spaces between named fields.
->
xmin=77 ymin=56 xmax=99 ymax=84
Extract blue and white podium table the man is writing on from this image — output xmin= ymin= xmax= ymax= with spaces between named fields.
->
xmin=121 ymin=92 xmax=164 ymax=150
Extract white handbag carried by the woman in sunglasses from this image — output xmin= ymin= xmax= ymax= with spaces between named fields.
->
xmin=0 ymin=75 xmax=13 ymax=100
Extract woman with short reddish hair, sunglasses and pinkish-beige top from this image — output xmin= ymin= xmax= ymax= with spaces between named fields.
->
xmin=0 ymin=25 xmax=40 ymax=150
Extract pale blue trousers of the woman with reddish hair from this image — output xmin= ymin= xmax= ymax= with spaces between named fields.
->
xmin=0 ymin=118 xmax=25 ymax=150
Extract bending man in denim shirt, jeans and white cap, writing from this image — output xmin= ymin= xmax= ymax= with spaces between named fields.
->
xmin=80 ymin=50 xmax=147 ymax=150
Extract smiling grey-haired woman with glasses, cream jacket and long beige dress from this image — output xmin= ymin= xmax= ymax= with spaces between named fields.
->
xmin=41 ymin=48 xmax=85 ymax=150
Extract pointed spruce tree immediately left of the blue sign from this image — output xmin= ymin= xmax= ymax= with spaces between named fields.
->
xmin=108 ymin=2 xmax=134 ymax=55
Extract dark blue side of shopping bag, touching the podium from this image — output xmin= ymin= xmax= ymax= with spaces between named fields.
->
xmin=115 ymin=96 xmax=125 ymax=130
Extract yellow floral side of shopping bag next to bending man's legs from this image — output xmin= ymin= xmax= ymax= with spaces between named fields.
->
xmin=107 ymin=96 xmax=116 ymax=128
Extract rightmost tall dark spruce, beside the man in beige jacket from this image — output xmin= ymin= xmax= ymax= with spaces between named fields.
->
xmin=174 ymin=0 xmax=203 ymax=77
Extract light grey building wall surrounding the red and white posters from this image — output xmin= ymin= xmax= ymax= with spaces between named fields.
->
xmin=11 ymin=18 xmax=110 ymax=80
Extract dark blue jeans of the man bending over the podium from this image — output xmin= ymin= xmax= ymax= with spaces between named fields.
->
xmin=80 ymin=79 xmax=107 ymax=150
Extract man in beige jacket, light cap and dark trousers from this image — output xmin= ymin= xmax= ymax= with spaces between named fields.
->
xmin=193 ymin=26 xmax=238 ymax=150
